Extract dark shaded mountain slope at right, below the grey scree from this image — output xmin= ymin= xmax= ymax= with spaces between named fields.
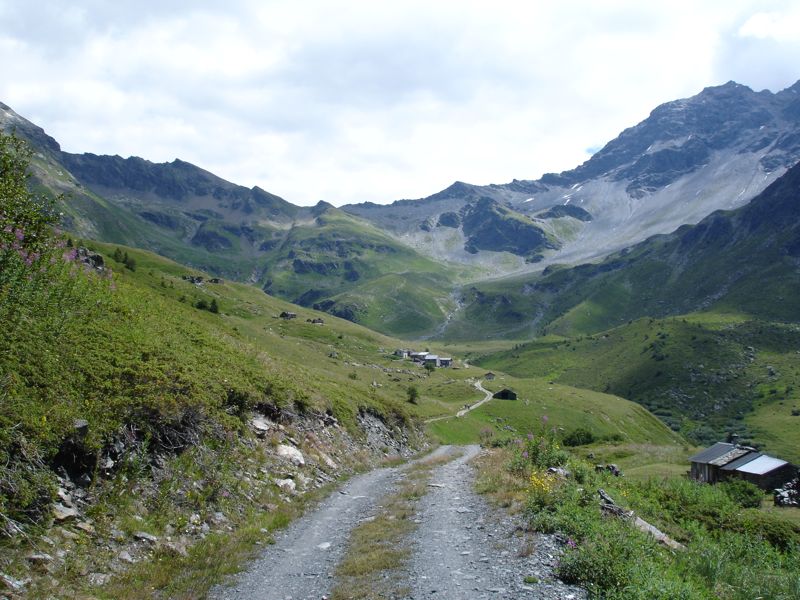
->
xmin=445 ymin=157 xmax=800 ymax=337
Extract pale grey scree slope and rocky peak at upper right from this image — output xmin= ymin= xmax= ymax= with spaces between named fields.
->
xmin=343 ymin=82 xmax=800 ymax=272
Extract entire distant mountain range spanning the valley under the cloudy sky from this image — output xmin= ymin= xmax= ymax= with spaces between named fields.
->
xmin=0 ymin=82 xmax=800 ymax=339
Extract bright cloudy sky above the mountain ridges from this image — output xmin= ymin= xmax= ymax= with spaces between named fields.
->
xmin=0 ymin=0 xmax=800 ymax=205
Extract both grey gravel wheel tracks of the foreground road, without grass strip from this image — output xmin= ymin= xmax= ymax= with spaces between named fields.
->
xmin=210 ymin=446 xmax=586 ymax=600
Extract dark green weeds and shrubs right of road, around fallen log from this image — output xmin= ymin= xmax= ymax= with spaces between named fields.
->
xmin=478 ymin=428 xmax=800 ymax=600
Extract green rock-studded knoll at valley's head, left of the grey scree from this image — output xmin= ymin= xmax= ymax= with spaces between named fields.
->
xmin=263 ymin=207 xmax=467 ymax=337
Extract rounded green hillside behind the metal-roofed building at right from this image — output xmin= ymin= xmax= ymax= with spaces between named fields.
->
xmin=479 ymin=313 xmax=800 ymax=460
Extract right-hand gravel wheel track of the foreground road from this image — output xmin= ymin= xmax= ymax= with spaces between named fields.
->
xmin=408 ymin=446 xmax=587 ymax=600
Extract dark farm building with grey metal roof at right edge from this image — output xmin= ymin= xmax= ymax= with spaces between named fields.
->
xmin=689 ymin=442 xmax=796 ymax=490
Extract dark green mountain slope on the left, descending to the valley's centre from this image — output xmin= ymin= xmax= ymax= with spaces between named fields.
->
xmin=0 ymin=105 xmax=465 ymax=336
